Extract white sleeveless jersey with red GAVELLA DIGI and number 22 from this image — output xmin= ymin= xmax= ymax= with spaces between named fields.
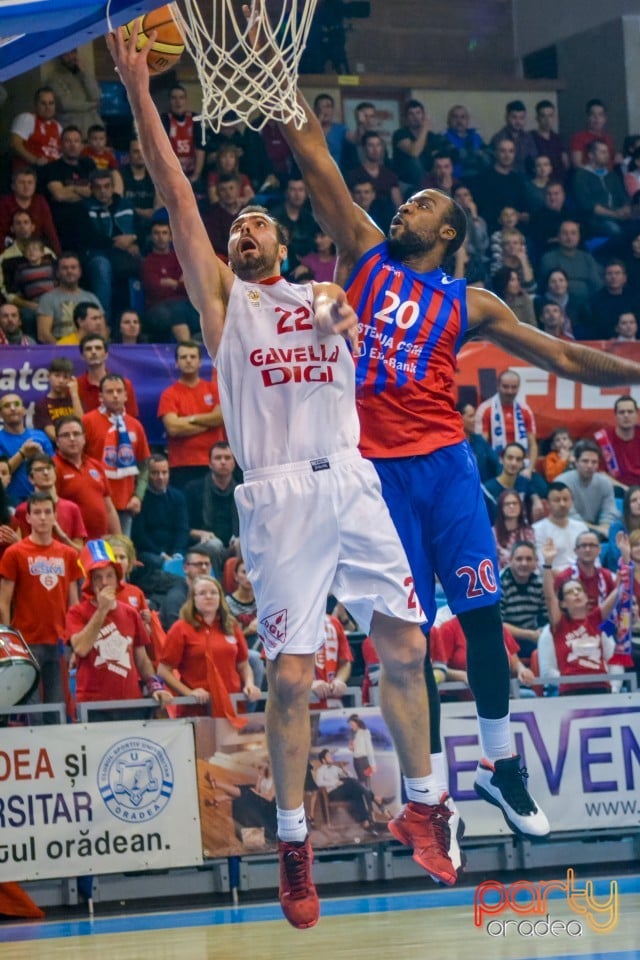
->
xmin=215 ymin=277 xmax=360 ymax=470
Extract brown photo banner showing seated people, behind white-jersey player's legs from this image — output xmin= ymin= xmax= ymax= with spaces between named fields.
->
xmin=196 ymin=708 xmax=402 ymax=857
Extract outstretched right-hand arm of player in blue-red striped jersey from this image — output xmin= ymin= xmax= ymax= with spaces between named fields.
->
xmin=467 ymin=287 xmax=640 ymax=387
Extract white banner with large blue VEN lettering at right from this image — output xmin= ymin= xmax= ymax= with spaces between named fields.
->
xmin=442 ymin=692 xmax=640 ymax=837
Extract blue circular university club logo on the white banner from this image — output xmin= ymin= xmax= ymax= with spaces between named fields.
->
xmin=98 ymin=737 xmax=174 ymax=823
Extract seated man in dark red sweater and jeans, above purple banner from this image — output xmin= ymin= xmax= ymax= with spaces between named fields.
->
xmin=141 ymin=223 xmax=200 ymax=343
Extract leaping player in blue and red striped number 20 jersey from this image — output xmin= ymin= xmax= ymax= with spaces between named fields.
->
xmin=266 ymin=45 xmax=640 ymax=863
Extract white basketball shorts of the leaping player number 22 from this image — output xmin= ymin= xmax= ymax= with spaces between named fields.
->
xmin=235 ymin=451 xmax=424 ymax=660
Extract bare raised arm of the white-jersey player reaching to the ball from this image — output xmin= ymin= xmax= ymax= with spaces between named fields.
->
xmin=107 ymin=23 xmax=233 ymax=356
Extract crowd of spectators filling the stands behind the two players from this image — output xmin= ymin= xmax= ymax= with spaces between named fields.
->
xmin=0 ymin=62 xmax=640 ymax=716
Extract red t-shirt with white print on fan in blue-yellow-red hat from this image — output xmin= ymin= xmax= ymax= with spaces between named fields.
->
xmin=67 ymin=599 xmax=149 ymax=703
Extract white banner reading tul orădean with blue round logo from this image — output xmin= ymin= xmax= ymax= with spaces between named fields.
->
xmin=0 ymin=720 xmax=202 ymax=881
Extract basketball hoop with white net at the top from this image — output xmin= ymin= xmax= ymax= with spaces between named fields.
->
xmin=171 ymin=0 xmax=317 ymax=131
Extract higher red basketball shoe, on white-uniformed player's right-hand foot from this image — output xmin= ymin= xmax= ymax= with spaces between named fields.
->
xmin=388 ymin=798 xmax=458 ymax=887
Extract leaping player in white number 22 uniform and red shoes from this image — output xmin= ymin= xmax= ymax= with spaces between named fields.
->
xmin=108 ymin=24 xmax=456 ymax=927
